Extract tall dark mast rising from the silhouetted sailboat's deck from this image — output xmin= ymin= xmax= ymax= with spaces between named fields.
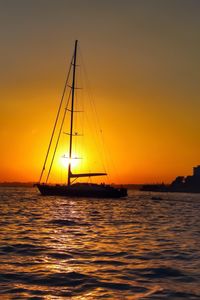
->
xmin=67 ymin=40 xmax=78 ymax=185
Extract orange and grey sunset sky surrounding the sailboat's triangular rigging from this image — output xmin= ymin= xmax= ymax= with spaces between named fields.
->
xmin=0 ymin=0 xmax=200 ymax=183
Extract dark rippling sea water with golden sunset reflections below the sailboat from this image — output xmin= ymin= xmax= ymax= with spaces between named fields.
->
xmin=0 ymin=188 xmax=200 ymax=300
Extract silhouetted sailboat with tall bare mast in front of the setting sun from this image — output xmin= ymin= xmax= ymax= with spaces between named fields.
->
xmin=36 ymin=40 xmax=127 ymax=198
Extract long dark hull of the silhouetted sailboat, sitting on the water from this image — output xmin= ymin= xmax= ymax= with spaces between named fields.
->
xmin=36 ymin=184 xmax=127 ymax=198
